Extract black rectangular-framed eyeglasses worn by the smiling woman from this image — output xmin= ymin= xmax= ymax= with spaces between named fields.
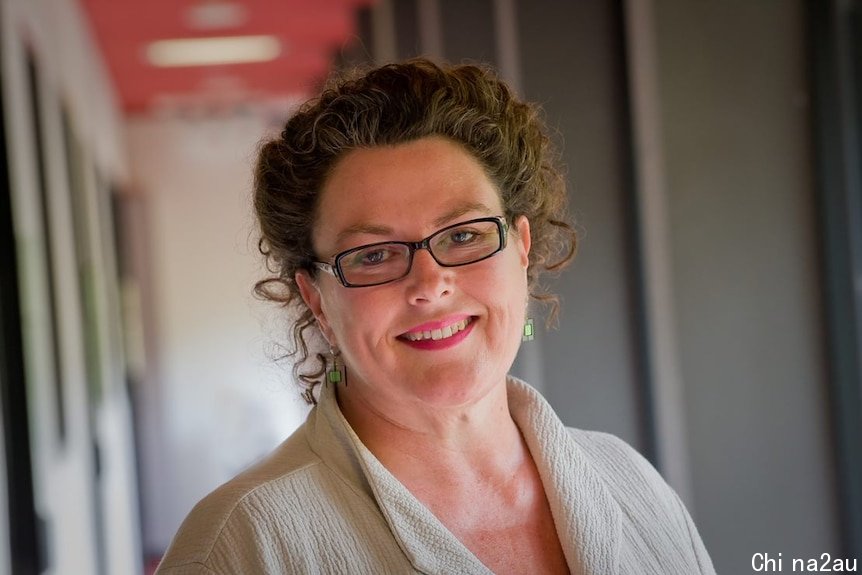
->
xmin=312 ymin=216 xmax=509 ymax=287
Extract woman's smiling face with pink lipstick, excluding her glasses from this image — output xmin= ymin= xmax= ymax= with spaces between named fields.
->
xmin=296 ymin=137 xmax=530 ymax=410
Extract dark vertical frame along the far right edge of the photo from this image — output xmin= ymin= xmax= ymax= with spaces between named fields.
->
xmin=806 ymin=0 xmax=862 ymax=557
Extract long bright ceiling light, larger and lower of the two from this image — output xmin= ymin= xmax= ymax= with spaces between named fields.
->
xmin=147 ymin=36 xmax=281 ymax=68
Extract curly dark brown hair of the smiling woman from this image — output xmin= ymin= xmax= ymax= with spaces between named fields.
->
xmin=254 ymin=58 xmax=576 ymax=402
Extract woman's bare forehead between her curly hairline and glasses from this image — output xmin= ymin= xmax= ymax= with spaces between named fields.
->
xmin=314 ymin=137 xmax=502 ymax=248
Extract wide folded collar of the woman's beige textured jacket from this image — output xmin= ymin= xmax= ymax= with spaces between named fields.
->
xmin=307 ymin=377 xmax=621 ymax=575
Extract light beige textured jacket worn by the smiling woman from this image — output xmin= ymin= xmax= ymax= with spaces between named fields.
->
xmin=158 ymin=378 xmax=715 ymax=575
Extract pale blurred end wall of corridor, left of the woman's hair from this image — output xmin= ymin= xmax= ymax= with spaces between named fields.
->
xmin=127 ymin=116 xmax=314 ymax=553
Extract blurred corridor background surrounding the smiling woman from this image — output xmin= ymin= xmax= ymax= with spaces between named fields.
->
xmin=0 ymin=0 xmax=862 ymax=574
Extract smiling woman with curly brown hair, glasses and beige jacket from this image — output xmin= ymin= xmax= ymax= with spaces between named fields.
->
xmin=160 ymin=60 xmax=714 ymax=575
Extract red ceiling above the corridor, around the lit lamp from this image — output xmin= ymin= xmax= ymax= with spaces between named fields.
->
xmin=80 ymin=0 xmax=373 ymax=114
